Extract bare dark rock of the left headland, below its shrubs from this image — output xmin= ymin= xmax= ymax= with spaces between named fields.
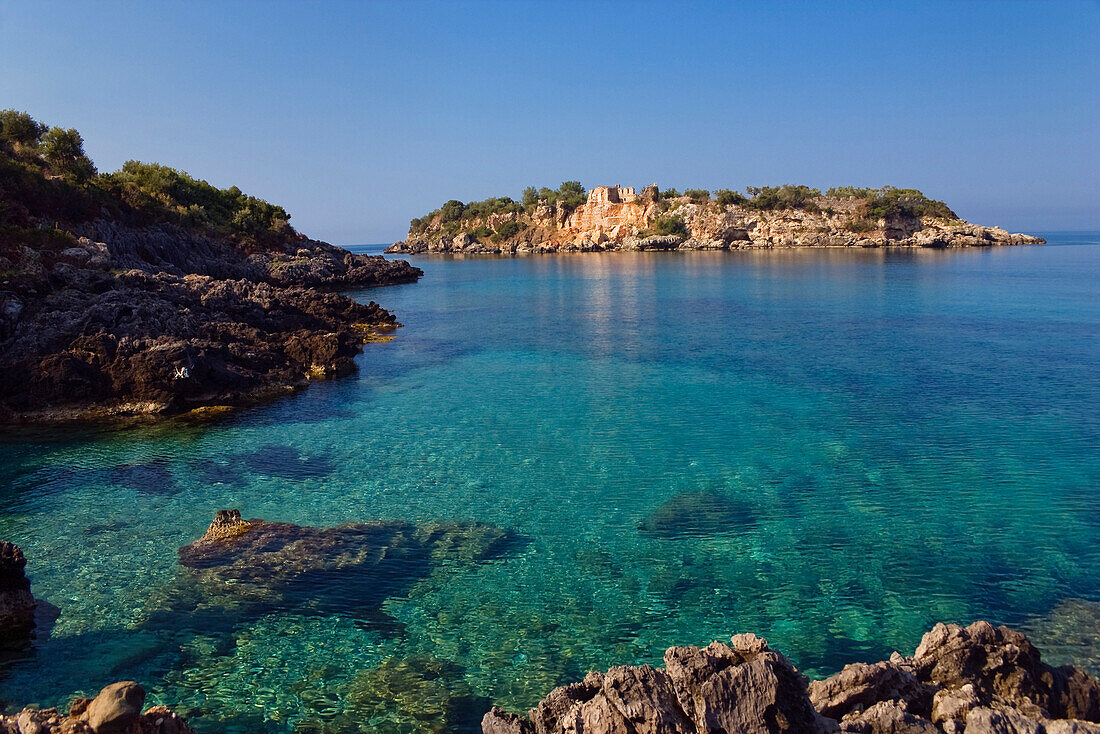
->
xmin=0 ymin=220 xmax=421 ymax=423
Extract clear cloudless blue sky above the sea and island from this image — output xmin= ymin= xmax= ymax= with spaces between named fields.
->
xmin=0 ymin=0 xmax=1100 ymax=244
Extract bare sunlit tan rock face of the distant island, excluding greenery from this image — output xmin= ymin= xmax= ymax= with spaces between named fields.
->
xmin=387 ymin=186 xmax=1044 ymax=254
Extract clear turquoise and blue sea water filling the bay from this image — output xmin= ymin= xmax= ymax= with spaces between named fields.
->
xmin=0 ymin=233 xmax=1100 ymax=732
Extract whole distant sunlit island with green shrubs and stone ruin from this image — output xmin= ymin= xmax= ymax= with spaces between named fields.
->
xmin=386 ymin=182 xmax=1044 ymax=255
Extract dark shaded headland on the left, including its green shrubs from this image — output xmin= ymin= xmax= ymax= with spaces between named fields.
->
xmin=0 ymin=110 xmax=422 ymax=424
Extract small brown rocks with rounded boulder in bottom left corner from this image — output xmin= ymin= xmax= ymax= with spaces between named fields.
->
xmin=0 ymin=680 xmax=194 ymax=734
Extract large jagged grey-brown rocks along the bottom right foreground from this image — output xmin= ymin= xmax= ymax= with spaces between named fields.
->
xmin=482 ymin=622 xmax=1100 ymax=734
